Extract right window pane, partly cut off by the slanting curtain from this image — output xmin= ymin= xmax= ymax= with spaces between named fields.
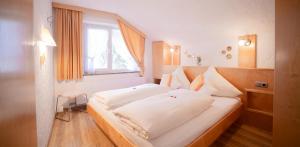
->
xmin=112 ymin=29 xmax=139 ymax=71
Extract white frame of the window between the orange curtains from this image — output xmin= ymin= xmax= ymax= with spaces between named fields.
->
xmin=83 ymin=22 xmax=140 ymax=75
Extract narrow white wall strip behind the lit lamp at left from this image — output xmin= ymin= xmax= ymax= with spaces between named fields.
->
xmin=33 ymin=0 xmax=55 ymax=147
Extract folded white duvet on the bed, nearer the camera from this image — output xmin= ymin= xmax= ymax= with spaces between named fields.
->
xmin=113 ymin=89 xmax=214 ymax=140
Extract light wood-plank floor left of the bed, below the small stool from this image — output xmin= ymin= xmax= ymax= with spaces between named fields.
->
xmin=49 ymin=112 xmax=114 ymax=147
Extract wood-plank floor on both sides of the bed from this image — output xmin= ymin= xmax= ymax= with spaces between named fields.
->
xmin=49 ymin=112 xmax=272 ymax=147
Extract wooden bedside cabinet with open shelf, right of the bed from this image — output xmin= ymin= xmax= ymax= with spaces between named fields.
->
xmin=245 ymin=89 xmax=274 ymax=132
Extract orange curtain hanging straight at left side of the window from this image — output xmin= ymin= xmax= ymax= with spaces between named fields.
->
xmin=55 ymin=8 xmax=83 ymax=81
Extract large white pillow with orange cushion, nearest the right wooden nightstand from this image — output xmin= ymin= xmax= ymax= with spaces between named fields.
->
xmin=190 ymin=67 xmax=242 ymax=97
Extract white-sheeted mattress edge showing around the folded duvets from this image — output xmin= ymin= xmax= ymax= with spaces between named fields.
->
xmin=89 ymin=97 xmax=241 ymax=147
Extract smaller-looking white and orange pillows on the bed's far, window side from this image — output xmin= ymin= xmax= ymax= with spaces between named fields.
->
xmin=160 ymin=67 xmax=190 ymax=89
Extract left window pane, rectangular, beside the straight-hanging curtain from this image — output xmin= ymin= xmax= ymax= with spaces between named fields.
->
xmin=87 ymin=28 xmax=109 ymax=71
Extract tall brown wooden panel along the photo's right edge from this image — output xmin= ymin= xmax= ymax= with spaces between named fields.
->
xmin=273 ymin=0 xmax=300 ymax=147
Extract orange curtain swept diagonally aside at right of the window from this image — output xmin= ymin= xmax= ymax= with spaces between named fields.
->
xmin=118 ymin=19 xmax=145 ymax=76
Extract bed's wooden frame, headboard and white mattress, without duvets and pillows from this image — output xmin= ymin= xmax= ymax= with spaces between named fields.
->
xmin=87 ymin=66 xmax=273 ymax=147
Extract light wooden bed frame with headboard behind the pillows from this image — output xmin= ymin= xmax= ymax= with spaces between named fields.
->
xmin=87 ymin=67 xmax=273 ymax=147
